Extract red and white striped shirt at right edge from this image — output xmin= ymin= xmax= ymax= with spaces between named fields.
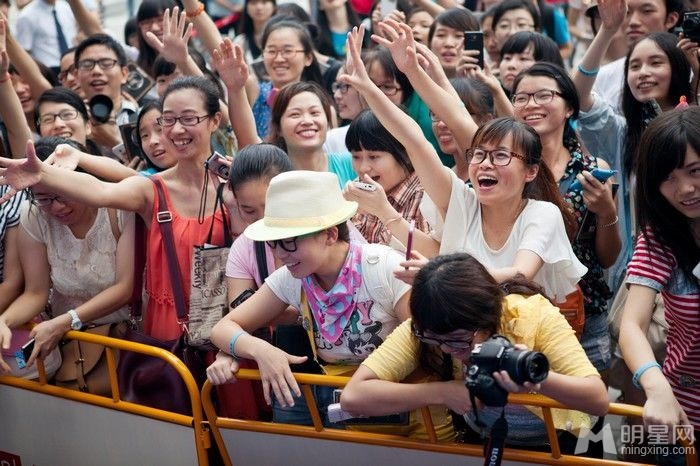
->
xmin=627 ymin=230 xmax=700 ymax=429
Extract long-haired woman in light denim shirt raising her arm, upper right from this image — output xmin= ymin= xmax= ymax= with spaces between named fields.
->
xmin=573 ymin=0 xmax=700 ymax=288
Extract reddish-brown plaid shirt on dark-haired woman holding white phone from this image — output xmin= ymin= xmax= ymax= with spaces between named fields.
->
xmin=352 ymin=173 xmax=430 ymax=244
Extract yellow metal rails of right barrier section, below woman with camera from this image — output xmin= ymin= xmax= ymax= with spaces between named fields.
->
xmin=201 ymin=369 xmax=698 ymax=466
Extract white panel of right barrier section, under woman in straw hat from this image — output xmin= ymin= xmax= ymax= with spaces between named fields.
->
xmin=220 ymin=428 xmax=528 ymax=466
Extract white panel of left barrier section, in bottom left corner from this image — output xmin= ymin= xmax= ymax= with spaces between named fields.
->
xmin=0 ymin=385 xmax=197 ymax=466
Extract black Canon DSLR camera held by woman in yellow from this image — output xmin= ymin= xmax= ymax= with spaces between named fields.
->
xmin=466 ymin=335 xmax=549 ymax=407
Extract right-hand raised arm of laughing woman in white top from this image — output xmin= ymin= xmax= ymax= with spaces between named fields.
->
xmin=372 ymin=20 xmax=478 ymax=148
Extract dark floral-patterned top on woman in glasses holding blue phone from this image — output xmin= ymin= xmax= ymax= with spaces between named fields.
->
xmin=559 ymin=140 xmax=613 ymax=315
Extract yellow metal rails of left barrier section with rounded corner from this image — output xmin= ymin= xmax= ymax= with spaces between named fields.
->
xmin=0 ymin=330 xmax=211 ymax=466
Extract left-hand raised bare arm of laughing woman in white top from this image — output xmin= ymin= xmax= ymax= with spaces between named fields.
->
xmin=337 ymin=27 xmax=452 ymax=212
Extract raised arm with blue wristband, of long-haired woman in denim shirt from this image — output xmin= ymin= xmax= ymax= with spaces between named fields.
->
xmin=571 ymin=0 xmax=627 ymax=112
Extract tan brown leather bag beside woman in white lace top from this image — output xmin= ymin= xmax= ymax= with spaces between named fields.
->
xmin=55 ymin=322 xmax=127 ymax=396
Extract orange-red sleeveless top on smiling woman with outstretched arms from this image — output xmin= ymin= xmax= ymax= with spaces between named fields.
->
xmin=144 ymin=175 xmax=224 ymax=340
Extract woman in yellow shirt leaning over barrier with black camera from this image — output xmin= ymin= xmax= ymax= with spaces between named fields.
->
xmin=341 ymin=253 xmax=608 ymax=442
